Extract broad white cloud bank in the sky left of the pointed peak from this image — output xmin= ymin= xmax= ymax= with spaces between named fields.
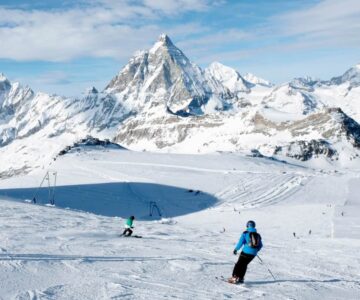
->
xmin=0 ymin=0 xmax=216 ymax=61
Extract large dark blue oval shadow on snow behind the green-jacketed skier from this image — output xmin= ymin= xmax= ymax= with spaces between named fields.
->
xmin=0 ymin=182 xmax=217 ymax=220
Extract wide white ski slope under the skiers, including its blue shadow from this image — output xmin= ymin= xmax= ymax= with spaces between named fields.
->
xmin=0 ymin=147 xmax=360 ymax=299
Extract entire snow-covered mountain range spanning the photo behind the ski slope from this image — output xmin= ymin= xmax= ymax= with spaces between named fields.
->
xmin=0 ymin=35 xmax=360 ymax=176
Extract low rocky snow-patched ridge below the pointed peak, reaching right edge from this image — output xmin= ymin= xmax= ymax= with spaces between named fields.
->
xmin=115 ymin=108 xmax=360 ymax=161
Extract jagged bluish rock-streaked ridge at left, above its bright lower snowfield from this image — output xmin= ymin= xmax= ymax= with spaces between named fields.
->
xmin=0 ymin=77 xmax=129 ymax=146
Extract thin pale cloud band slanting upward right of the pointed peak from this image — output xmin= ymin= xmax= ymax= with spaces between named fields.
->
xmin=181 ymin=0 xmax=360 ymax=64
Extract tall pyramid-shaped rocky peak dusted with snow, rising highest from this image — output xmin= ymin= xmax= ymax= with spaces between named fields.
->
xmin=105 ymin=35 xmax=232 ymax=115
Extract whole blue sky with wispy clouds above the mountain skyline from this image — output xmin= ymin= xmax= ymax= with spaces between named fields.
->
xmin=0 ymin=0 xmax=360 ymax=96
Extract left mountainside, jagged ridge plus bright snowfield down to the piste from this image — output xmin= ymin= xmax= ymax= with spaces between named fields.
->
xmin=0 ymin=76 xmax=131 ymax=177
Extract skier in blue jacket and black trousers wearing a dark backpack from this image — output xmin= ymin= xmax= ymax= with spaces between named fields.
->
xmin=228 ymin=221 xmax=263 ymax=283
